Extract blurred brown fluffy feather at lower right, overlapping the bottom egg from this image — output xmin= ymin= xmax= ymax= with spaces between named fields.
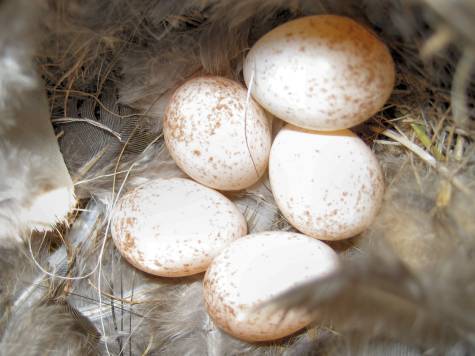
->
xmin=274 ymin=163 xmax=475 ymax=353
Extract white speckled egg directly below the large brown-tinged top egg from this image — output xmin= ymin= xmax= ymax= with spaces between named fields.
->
xmin=269 ymin=125 xmax=384 ymax=240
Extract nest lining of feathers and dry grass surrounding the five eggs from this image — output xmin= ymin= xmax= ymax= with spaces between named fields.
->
xmin=0 ymin=0 xmax=475 ymax=355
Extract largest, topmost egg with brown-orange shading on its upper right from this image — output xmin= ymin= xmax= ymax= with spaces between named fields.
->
xmin=244 ymin=15 xmax=395 ymax=131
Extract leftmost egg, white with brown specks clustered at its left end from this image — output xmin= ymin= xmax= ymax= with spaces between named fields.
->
xmin=111 ymin=178 xmax=247 ymax=277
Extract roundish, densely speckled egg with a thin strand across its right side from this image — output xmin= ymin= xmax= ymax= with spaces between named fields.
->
xmin=163 ymin=76 xmax=271 ymax=190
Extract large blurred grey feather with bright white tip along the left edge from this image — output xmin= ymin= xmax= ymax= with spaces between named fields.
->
xmin=0 ymin=1 xmax=75 ymax=240
